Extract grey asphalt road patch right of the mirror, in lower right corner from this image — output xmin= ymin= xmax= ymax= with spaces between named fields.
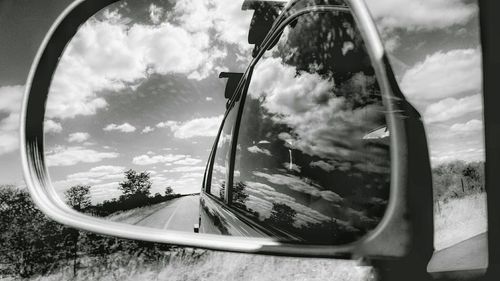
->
xmin=427 ymin=232 xmax=488 ymax=273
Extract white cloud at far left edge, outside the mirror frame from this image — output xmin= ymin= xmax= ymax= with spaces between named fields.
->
xmin=0 ymin=85 xmax=24 ymax=155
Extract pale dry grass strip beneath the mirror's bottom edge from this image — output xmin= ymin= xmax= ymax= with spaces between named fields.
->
xmin=22 ymin=250 xmax=375 ymax=281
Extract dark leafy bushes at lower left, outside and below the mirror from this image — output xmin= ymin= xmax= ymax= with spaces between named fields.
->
xmin=0 ymin=185 xmax=194 ymax=277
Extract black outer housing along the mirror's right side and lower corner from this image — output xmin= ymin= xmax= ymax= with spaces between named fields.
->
xmin=371 ymin=56 xmax=434 ymax=281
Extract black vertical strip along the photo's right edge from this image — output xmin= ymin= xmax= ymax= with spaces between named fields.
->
xmin=478 ymin=0 xmax=500 ymax=281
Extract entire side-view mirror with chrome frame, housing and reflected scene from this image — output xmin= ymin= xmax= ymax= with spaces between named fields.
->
xmin=21 ymin=0 xmax=434 ymax=280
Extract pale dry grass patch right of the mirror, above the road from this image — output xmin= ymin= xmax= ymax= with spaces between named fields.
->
xmin=434 ymin=190 xmax=488 ymax=250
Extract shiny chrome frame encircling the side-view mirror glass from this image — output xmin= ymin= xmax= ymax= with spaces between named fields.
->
xmin=20 ymin=0 xmax=432 ymax=258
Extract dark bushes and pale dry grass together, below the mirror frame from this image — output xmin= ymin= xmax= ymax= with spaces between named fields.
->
xmin=0 ymin=186 xmax=375 ymax=281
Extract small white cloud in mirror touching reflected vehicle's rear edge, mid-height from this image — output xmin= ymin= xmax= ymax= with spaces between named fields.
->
xmin=156 ymin=115 xmax=223 ymax=139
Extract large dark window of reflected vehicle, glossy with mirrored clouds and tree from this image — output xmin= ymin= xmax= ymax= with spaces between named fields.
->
xmin=232 ymin=12 xmax=390 ymax=244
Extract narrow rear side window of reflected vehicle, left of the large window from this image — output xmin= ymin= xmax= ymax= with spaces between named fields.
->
xmin=209 ymin=100 xmax=237 ymax=200
